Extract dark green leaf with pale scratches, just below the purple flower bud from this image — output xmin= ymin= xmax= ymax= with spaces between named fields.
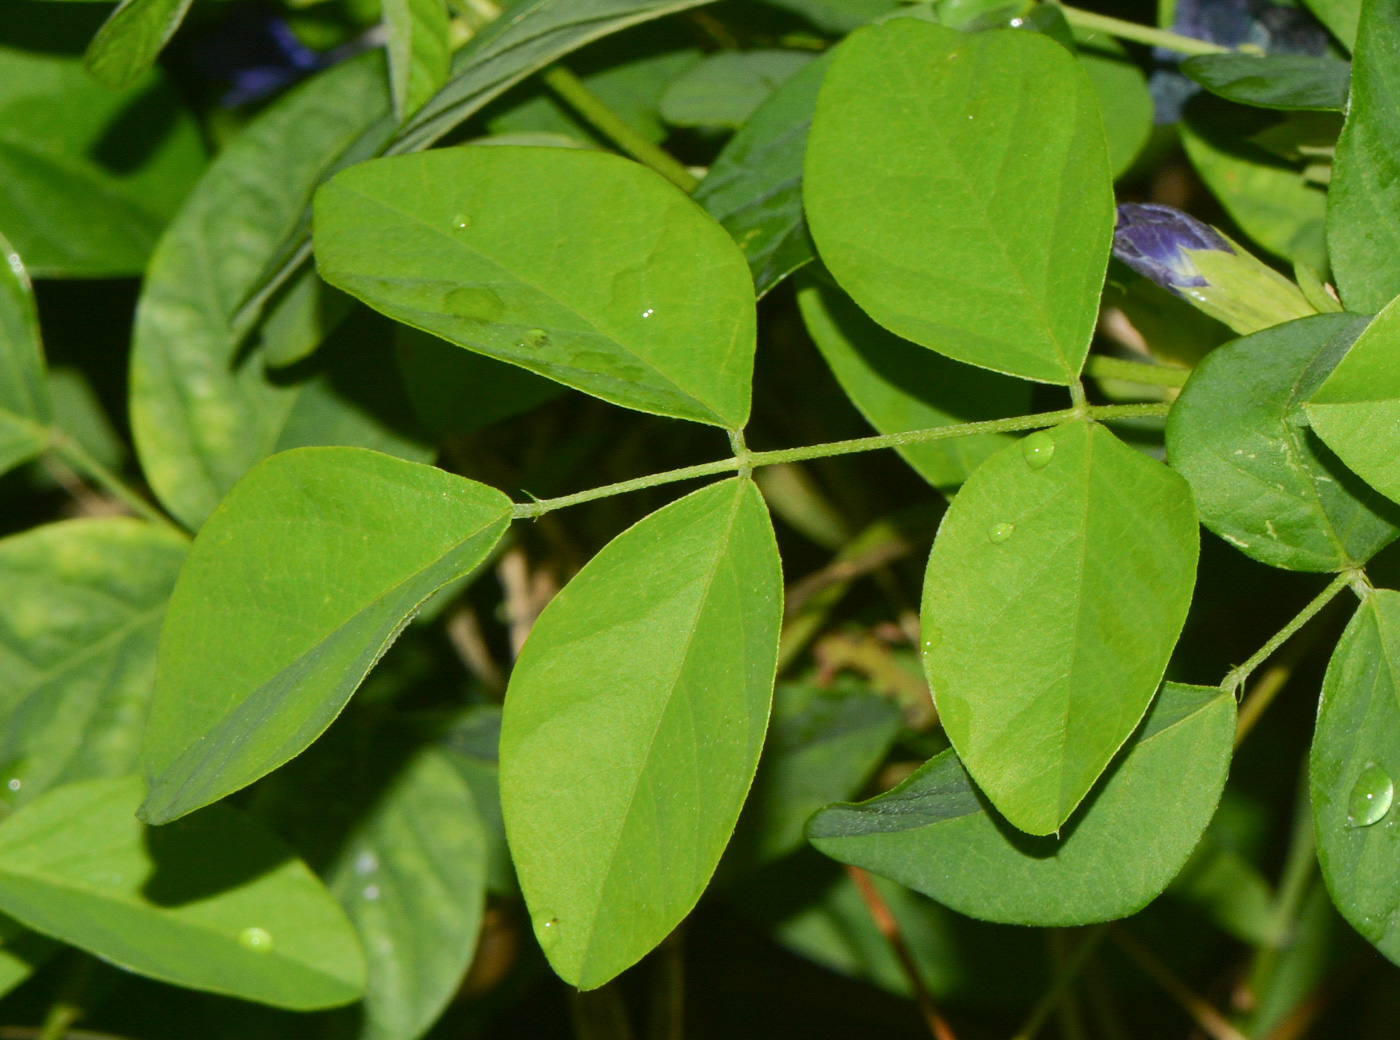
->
xmin=1166 ymin=314 xmax=1400 ymax=571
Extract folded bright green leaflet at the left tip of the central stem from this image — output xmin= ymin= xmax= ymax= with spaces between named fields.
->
xmin=133 ymin=448 xmax=511 ymax=823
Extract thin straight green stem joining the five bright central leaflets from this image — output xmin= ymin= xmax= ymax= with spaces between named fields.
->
xmin=512 ymin=405 xmax=1172 ymax=519
